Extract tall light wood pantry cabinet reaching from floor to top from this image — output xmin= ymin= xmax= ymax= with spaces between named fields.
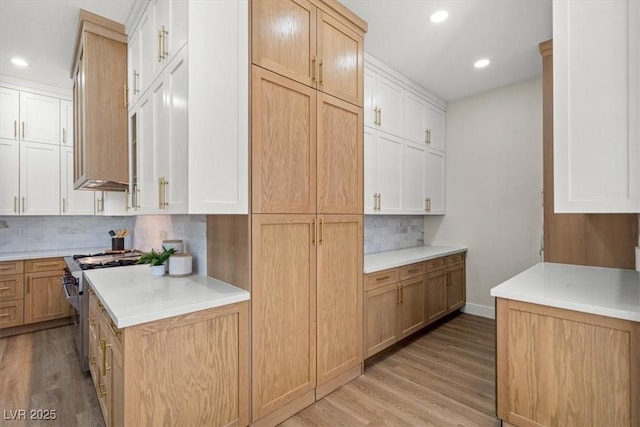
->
xmin=207 ymin=0 xmax=367 ymax=426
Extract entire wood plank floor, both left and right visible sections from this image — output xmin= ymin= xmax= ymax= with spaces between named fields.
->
xmin=0 ymin=314 xmax=500 ymax=427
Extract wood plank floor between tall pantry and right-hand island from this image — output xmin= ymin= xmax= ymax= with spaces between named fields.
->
xmin=281 ymin=313 xmax=500 ymax=427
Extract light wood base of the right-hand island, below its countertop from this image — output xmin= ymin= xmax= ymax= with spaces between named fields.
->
xmin=496 ymin=298 xmax=640 ymax=426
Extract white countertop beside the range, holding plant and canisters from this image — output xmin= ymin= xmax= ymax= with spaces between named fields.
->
xmin=84 ymin=264 xmax=249 ymax=328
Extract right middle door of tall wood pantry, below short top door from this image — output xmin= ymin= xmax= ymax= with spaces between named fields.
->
xmin=316 ymin=93 xmax=364 ymax=214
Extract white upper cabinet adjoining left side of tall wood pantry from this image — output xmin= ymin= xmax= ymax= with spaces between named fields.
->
xmin=129 ymin=0 xmax=249 ymax=214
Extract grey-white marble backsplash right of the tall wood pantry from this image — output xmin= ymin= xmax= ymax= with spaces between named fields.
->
xmin=364 ymin=215 xmax=424 ymax=254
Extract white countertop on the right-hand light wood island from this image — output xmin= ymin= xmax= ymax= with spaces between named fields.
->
xmin=491 ymin=262 xmax=640 ymax=322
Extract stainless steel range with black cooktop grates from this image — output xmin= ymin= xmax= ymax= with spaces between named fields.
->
xmin=62 ymin=250 xmax=141 ymax=372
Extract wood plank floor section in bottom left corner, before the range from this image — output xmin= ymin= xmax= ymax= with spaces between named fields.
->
xmin=0 ymin=325 xmax=104 ymax=427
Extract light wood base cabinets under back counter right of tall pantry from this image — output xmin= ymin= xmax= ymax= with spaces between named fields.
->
xmin=364 ymin=253 xmax=466 ymax=358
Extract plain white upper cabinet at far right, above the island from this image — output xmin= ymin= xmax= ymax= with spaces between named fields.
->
xmin=553 ymin=0 xmax=640 ymax=213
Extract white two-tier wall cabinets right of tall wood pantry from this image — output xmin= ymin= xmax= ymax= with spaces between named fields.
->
xmin=364 ymin=55 xmax=446 ymax=215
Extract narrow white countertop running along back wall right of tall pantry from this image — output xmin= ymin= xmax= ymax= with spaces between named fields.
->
xmin=364 ymin=246 xmax=467 ymax=273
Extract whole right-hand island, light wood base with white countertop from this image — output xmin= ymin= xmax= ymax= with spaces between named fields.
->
xmin=491 ymin=263 xmax=640 ymax=426
